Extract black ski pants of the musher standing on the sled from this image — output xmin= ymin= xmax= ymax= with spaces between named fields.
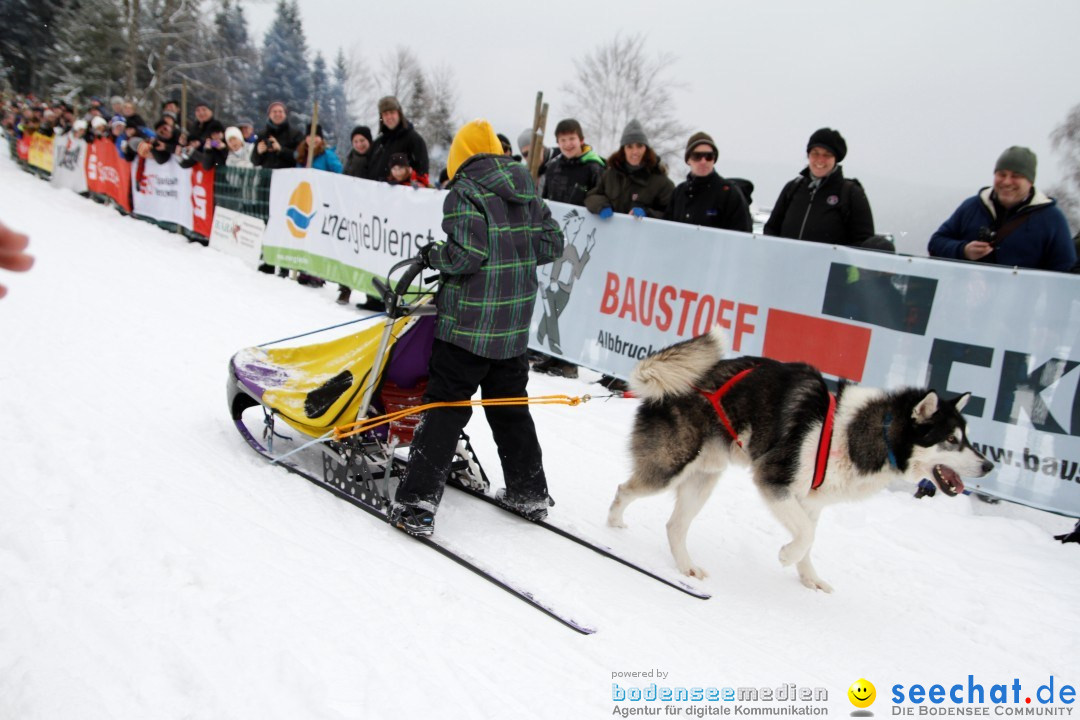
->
xmin=396 ymin=339 xmax=548 ymax=507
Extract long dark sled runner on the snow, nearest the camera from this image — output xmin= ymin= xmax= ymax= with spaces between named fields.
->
xmin=238 ymin=423 xmax=596 ymax=635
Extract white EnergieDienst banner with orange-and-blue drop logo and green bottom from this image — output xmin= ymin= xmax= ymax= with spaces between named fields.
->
xmin=262 ymin=168 xmax=446 ymax=293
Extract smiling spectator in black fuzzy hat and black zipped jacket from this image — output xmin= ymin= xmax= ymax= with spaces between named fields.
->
xmin=765 ymin=127 xmax=874 ymax=245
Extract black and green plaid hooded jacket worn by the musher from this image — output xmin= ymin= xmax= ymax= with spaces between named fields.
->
xmin=429 ymin=154 xmax=563 ymax=359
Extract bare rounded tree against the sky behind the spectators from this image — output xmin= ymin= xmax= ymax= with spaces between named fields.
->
xmin=563 ymin=33 xmax=688 ymax=168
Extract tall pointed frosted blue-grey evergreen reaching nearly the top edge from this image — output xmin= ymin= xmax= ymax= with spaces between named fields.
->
xmin=257 ymin=0 xmax=311 ymax=122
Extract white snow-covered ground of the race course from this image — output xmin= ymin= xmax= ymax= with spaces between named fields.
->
xmin=0 ymin=148 xmax=1080 ymax=720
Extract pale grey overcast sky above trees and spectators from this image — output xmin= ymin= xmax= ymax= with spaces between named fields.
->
xmin=245 ymin=0 xmax=1080 ymax=245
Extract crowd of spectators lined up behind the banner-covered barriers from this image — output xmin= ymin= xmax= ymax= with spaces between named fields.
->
xmin=0 ymin=96 xmax=1078 ymax=287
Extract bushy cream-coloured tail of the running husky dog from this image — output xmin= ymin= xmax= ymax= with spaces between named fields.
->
xmin=630 ymin=325 xmax=727 ymax=400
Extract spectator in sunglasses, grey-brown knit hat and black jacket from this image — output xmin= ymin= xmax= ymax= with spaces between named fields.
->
xmin=666 ymin=133 xmax=753 ymax=232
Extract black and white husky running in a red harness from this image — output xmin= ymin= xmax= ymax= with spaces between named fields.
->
xmin=608 ymin=328 xmax=994 ymax=593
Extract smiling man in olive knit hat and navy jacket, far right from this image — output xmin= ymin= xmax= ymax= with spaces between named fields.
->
xmin=928 ymin=146 xmax=1077 ymax=272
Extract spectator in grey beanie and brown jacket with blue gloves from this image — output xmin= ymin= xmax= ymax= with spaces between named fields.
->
xmin=585 ymin=120 xmax=675 ymax=218
